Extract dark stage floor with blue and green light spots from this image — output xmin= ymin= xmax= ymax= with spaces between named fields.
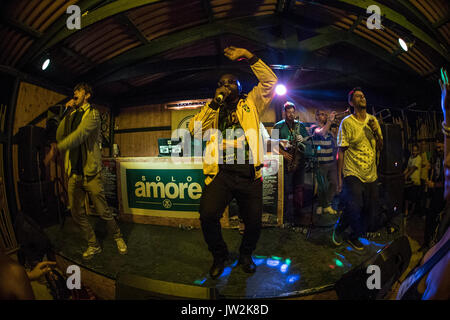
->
xmin=45 ymin=217 xmax=400 ymax=299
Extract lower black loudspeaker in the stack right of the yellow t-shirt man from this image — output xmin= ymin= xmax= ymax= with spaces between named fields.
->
xmin=378 ymin=174 xmax=405 ymax=217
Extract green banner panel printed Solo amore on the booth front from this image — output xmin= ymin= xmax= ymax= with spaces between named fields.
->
xmin=126 ymin=169 xmax=205 ymax=212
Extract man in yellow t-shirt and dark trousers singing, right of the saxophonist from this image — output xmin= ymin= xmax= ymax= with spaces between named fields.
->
xmin=332 ymin=88 xmax=383 ymax=251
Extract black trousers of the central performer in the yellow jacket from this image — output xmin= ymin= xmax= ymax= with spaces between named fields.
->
xmin=200 ymin=169 xmax=263 ymax=259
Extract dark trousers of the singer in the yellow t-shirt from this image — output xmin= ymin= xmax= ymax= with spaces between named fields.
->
xmin=337 ymin=176 xmax=378 ymax=239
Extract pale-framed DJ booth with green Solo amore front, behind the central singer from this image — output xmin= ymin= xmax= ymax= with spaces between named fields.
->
xmin=103 ymin=155 xmax=283 ymax=227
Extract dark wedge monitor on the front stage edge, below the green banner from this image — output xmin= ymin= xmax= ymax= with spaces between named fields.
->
xmin=116 ymin=273 xmax=217 ymax=300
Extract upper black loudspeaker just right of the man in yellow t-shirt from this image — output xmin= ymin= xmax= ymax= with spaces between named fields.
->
xmin=379 ymin=123 xmax=403 ymax=174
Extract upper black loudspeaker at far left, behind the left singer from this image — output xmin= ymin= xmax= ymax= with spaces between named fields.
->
xmin=15 ymin=126 xmax=46 ymax=182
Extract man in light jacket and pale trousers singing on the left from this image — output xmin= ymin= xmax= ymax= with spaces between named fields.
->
xmin=44 ymin=83 xmax=127 ymax=259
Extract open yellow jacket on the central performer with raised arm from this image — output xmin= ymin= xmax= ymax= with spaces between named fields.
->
xmin=189 ymin=59 xmax=278 ymax=185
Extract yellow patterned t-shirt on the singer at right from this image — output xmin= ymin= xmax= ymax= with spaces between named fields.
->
xmin=337 ymin=114 xmax=382 ymax=183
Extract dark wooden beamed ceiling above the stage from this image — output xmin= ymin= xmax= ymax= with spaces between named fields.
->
xmin=0 ymin=0 xmax=450 ymax=106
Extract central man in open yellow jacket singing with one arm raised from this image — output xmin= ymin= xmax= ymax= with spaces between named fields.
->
xmin=189 ymin=47 xmax=277 ymax=279
